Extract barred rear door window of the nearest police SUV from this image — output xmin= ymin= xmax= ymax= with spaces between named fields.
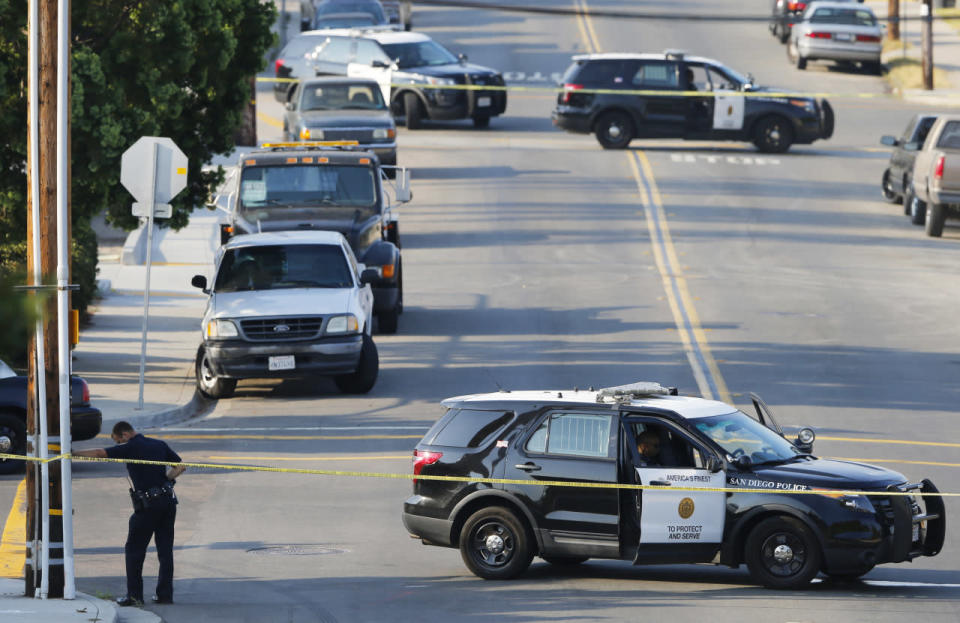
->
xmin=526 ymin=413 xmax=613 ymax=458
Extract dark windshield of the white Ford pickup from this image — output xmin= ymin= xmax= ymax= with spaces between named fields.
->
xmin=214 ymin=244 xmax=353 ymax=292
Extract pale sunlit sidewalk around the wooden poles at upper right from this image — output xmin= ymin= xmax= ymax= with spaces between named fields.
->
xmin=866 ymin=0 xmax=960 ymax=108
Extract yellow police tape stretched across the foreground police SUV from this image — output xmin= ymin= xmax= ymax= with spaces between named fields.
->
xmin=0 ymin=453 xmax=960 ymax=497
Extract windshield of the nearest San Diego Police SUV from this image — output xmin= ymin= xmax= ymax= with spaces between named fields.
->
xmin=692 ymin=411 xmax=803 ymax=464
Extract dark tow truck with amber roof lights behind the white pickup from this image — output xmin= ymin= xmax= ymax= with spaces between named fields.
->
xmin=211 ymin=141 xmax=412 ymax=333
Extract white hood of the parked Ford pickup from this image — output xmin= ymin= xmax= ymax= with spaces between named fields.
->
xmin=211 ymin=288 xmax=353 ymax=319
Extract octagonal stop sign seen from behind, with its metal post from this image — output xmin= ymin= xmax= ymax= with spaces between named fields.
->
xmin=120 ymin=136 xmax=187 ymax=409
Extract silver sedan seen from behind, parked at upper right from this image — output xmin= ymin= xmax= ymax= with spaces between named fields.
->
xmin=787 ymin=2 xmax=883 ymax=75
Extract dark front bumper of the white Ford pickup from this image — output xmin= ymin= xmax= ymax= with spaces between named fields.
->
xmin=205 ymin=334 xmax=363 ymax=379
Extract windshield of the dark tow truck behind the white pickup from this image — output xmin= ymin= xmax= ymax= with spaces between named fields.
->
xmin=240 ymin=164 xmax=377 ymax=210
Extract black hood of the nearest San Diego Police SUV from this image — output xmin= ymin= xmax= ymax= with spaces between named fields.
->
xmin=752 ymin=459 xmax=907 ymax=491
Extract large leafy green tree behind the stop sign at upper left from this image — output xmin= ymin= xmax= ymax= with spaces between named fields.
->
xmin=0 ymin=0 xmax=276 ymax=316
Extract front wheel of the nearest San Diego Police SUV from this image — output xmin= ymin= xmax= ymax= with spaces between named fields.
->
xmin=744 ymin=517 xmax=823 ymax=589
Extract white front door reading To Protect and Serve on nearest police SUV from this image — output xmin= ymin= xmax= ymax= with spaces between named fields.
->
xmin=623 ymin=415 xmax=726 ymax=564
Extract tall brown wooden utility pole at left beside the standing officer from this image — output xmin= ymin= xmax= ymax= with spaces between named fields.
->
xmin=25 ymin=0 xmax=69 ymax=597
